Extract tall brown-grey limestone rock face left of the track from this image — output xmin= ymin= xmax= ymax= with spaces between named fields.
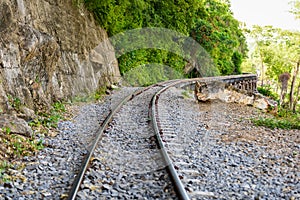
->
xmin=0 ymin=0 xmax=120 ymax=112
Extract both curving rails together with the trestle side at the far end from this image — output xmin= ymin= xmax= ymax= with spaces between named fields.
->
xmin=68 ymin=74 xmax=256 ymax=200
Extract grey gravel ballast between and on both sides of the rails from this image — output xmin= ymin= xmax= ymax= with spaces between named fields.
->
xmin=0 ymin=88 xmax=300 ymax=200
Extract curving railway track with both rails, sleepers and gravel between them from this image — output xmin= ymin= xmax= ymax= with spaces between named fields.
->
xmin=68 ymin=77 xmax=256 ymax=199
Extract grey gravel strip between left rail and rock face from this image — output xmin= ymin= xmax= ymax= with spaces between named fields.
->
xmin=0 ymin=88 xmax=137 ymax=200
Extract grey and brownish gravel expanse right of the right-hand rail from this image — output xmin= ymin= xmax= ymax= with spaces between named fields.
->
xmin=160 ymin=88 xmax=300 ymax=199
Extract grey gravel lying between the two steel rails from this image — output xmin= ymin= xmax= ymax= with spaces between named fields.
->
xmin=79 ymin=88 xmax=176 ymax=199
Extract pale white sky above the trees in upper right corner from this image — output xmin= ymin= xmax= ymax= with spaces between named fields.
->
xmin=231 ymin=0 xmax=300 ymax=30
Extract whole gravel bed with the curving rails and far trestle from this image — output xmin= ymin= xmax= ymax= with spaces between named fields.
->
xmin=0 ymin=75 xmax=300 ymax=200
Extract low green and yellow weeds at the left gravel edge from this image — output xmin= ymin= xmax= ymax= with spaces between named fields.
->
xmin=0 ymin=102 xmax=66 ymax=183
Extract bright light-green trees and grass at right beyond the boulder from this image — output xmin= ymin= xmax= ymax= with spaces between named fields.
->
xmin=243 ymin=0 xmax=300 ymax=129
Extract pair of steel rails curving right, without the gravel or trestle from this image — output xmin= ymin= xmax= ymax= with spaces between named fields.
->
xmin=67 ymin=75 xmax=254 ymax=200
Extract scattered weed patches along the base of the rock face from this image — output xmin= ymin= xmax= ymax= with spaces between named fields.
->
xmin=0 ymin=87 xmax=107 ymax=183
